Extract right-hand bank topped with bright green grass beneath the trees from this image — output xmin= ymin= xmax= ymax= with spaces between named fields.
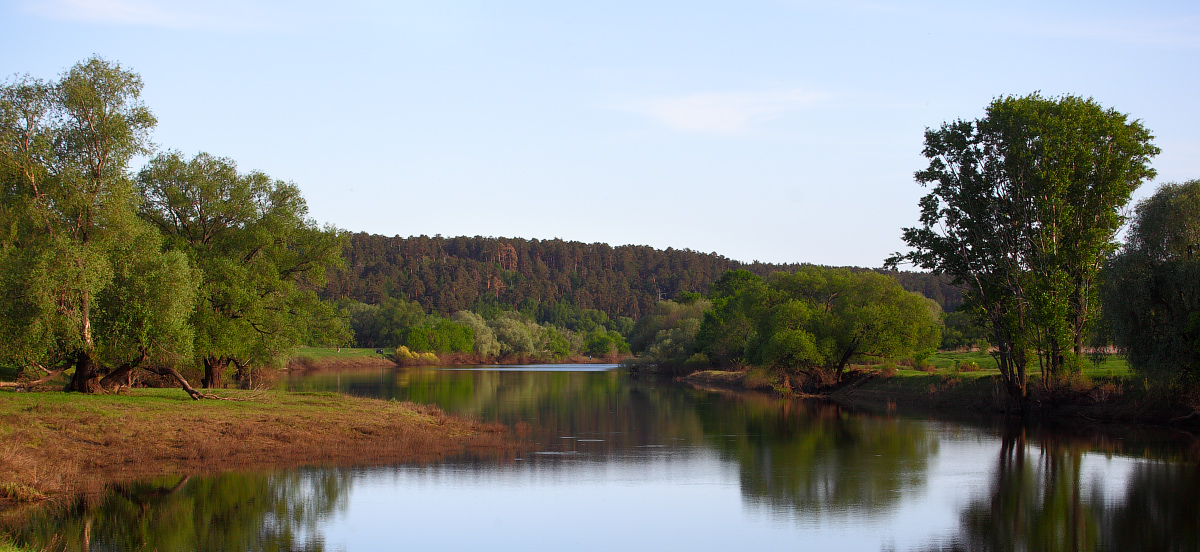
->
xmin=684 ymin=353 xmax=1190 ymax=424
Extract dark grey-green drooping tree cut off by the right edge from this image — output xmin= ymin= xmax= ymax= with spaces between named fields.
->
xmin=1104 ymin=180 xmax=1200 ymax=390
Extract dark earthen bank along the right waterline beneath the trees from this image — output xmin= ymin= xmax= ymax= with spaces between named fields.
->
xmin=679 ymin=368 xmax=1200 ymax=430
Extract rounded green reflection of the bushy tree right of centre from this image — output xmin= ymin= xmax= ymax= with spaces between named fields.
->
xmin=697 ymin=397 xmax=937 ymax=518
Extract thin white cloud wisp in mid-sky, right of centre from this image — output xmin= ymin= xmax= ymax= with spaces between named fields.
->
xmin=617 ymin=89 xmax=829 ymax=134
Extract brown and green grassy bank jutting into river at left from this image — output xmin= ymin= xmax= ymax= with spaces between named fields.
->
xmin=0 ymin=389 xmax=520 ymax=508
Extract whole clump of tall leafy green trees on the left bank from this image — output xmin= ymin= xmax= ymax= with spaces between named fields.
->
xmin=0 ymin=58 xmax=349 ymax=398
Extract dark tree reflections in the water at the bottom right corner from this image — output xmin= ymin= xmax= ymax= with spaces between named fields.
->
xmin=930 ymin=426 xmax=1200 ymax=551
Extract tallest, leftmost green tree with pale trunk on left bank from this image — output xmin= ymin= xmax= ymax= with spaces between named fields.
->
xmin=0 ymin=58 xmax=197 ymax=392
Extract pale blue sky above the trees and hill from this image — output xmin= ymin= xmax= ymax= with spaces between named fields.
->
xmin=0 ymin=0 xmax=1200 ymax=266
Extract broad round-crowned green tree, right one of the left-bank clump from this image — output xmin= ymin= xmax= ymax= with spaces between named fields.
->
xmin=138 ymin=151 xmax=349 ymax=388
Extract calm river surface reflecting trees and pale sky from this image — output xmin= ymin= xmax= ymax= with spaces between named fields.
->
xmin=11 ymin=365 xmax=1200 ymax=551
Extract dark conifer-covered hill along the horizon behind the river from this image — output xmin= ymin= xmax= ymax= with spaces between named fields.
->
xmin=323 ymin=233 xmax=960 ymax=319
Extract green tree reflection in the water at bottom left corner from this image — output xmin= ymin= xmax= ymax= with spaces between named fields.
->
xmin=13 ymin=469 xmax=350 ymax=551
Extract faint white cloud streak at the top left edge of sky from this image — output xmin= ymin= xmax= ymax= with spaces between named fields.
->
xmin=23 ymin=0 xmax=280 ymax=30
